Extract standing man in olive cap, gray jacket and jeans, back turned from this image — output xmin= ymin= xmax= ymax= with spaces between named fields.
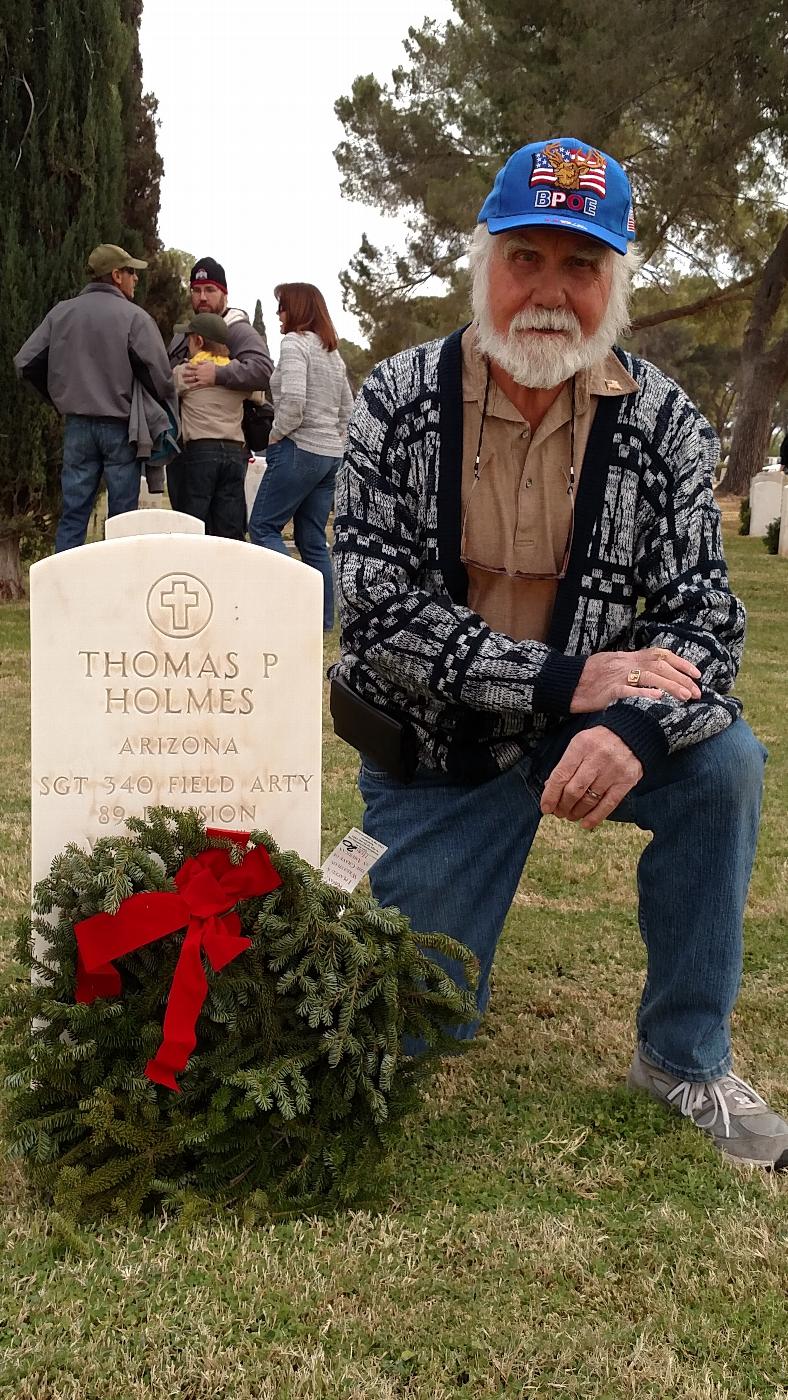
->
xmin=14 ymin=244 xmax=174 ymax=550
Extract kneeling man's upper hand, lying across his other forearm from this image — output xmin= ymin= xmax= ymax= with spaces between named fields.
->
xmin=570 ymin=647 xmax=700 ymax=714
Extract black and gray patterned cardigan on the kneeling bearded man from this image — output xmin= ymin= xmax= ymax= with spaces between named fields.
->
xmin=332 ymin=330 xmax=745 ymax=781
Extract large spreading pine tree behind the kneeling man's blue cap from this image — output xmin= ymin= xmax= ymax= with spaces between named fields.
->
xmin=335 ymin=0 xmax=788 ymax=490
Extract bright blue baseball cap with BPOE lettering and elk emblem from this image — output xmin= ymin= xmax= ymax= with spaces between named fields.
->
xmin=477 ymin=136 xmax=635 ymax=253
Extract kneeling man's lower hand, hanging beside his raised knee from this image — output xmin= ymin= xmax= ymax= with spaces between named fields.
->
xmin=542 ymin=725 xmax=642 ymax=832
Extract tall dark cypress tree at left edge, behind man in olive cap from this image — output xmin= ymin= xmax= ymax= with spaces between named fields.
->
xmin=0 ymin=0 xmax=170 ymax=598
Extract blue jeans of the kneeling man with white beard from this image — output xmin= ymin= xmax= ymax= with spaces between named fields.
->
xmin=360 ymin=718 xmax=766 ymax=1081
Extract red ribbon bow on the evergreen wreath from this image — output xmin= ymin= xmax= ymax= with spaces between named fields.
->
xmin=74 ymin=830 xmax=281 ymax=1093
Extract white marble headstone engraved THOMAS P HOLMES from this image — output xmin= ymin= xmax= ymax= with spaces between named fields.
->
xmin=31 ymin=529 xmax=323 ymax=882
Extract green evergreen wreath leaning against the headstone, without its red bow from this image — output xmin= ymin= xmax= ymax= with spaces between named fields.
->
xmin=3 ymin=808 xmax=476 ymax=1222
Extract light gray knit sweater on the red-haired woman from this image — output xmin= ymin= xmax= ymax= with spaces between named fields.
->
xmin=270 ymin=330 xmax=353 ymax=456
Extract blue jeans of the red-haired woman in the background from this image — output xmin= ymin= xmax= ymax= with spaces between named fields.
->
xmin=249 ymin=438 xmax=342 ymax=631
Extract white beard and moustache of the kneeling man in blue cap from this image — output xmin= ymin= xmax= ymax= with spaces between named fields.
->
xmin=477 ymin=298 xmax=619 ymax=389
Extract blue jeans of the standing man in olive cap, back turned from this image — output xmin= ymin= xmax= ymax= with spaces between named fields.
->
xmin=55 ymin=413 xmax=141 ymax=552
